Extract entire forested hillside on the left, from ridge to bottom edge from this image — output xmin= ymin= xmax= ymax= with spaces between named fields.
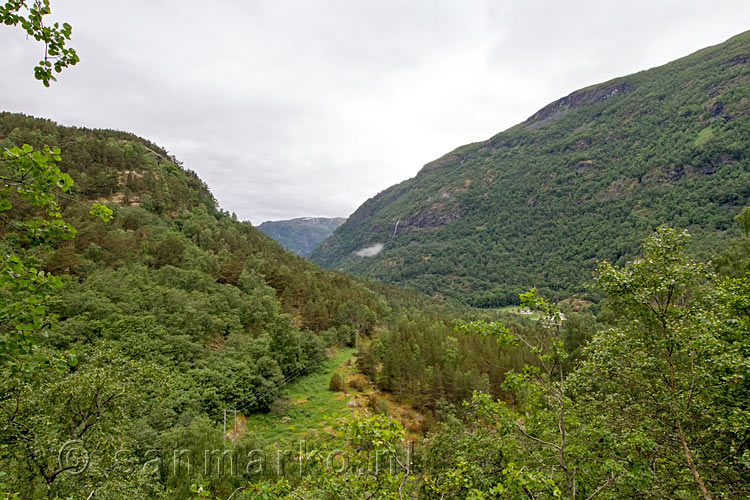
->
xmin=0 ymin=113 xmax=422 ymax=498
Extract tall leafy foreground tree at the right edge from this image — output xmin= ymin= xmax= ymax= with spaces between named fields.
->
xmin=574 ymin=227 xmax=750 ymax=500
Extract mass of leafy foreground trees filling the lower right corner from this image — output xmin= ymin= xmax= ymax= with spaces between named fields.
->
xmin=440 ymin=226 xmax=750 ymax=500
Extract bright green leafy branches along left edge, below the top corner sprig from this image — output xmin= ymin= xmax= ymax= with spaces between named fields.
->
xmin=0 ymin=144 xmax=112 ymax=374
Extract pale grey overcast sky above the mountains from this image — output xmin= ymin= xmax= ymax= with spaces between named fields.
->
xmin=0 ymin=0 xmax=750 ymax=224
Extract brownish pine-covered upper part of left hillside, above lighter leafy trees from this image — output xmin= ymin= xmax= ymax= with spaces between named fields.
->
xmin=0 ymin=113 xmax=384 ymax=331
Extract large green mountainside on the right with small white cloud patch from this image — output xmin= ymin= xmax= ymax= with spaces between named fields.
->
xmin=311 ymin=32 xmax=750 ymax=306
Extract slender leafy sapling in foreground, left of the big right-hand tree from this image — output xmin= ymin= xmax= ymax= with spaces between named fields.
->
xmin=453 ymin=289 xmax=617 ymax=499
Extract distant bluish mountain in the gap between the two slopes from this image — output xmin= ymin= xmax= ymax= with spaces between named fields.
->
xmin=258 ymin=217 xmax=346 ymax=257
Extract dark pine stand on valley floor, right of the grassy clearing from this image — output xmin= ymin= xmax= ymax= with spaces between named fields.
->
xmin=357 ymin=294 xmax=597 ymax=416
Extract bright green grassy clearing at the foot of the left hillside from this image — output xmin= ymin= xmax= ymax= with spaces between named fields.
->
xmin=246 ymin=348 xmax=356 ymax=443
